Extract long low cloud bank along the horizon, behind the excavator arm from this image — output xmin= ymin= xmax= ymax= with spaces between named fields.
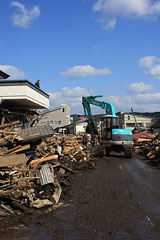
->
xmin=49 ymin=87 xmax=160 ymax=114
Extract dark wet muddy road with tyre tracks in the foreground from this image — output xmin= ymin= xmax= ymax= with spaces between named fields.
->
xmin=0 ymin=156 xmax=160 ymax=240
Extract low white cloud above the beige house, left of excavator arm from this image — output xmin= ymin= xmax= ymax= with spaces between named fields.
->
xmin=49 ymin=87 xmax=94 ymax=113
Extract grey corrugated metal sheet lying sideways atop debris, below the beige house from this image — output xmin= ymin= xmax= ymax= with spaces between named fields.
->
xmin=20 ymin=125 xmax=54 ymax=140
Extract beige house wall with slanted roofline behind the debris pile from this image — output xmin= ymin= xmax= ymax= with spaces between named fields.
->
xmin=39 ymin=104 xmax=70 ymax=129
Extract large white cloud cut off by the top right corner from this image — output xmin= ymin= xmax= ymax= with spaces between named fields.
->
xmin=93 ymin=0 xmax=160 ymax=29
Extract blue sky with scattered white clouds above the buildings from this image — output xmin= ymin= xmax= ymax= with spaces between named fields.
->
xmin=0 ymin=0 xmax=160 ymax=114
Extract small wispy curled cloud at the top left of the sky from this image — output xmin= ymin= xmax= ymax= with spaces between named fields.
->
xmin=11 ymin=1 xmax=40 ymax=28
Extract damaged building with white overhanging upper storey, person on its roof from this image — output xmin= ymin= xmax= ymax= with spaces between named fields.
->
xmin=0 ymin=74 xmax=49 ymax=128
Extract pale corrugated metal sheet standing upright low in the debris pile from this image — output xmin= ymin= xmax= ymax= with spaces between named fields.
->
xmin=39 ymin=163 xmax=54 ymax=185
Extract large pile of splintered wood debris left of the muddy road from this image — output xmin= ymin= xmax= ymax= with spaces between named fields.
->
xmin=0 ymin=123 xmax=98 ymax=216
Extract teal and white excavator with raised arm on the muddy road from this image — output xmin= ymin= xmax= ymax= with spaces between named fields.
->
xmin=82 ymin=95 xmax=133 ymax=157
